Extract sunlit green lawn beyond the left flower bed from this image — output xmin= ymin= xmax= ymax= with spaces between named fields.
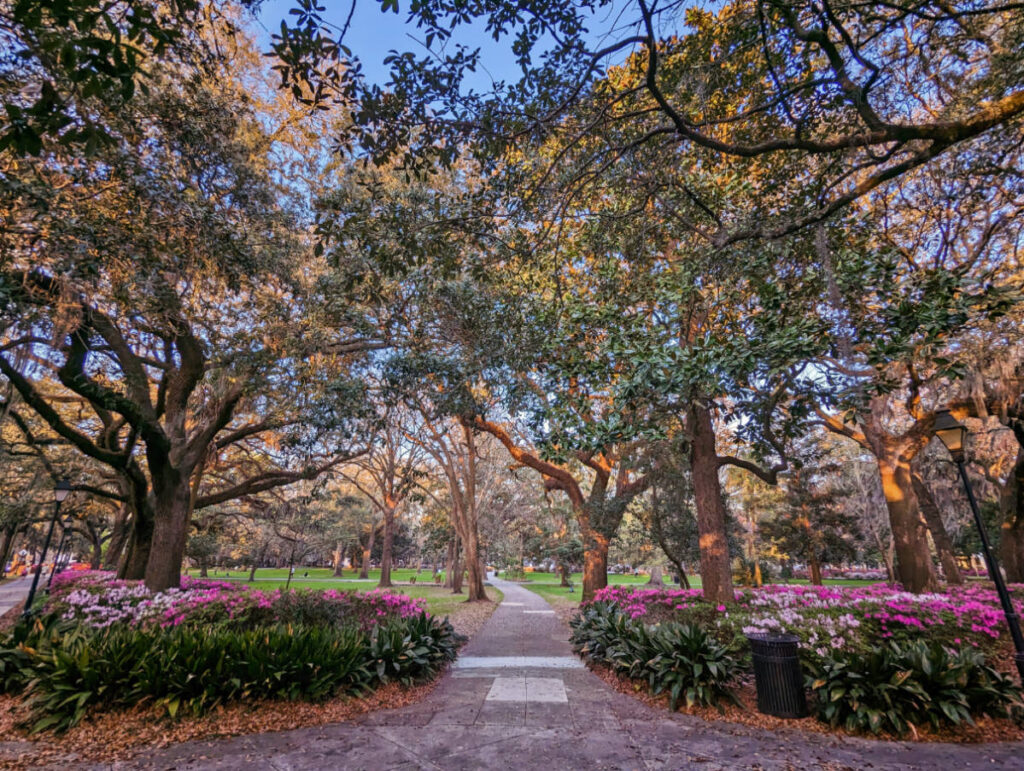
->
xmin=189 ymin=567 xmax=504 ymax=616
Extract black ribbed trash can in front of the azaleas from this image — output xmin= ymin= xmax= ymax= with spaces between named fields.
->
xmin=746 ymin=634 xmax=808 ymax=718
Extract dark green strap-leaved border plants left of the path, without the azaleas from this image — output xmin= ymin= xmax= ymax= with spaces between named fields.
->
xmin=6 ymin=613 xmax=463 ymax=731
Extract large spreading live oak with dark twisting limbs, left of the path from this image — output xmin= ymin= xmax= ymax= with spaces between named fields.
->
xmin=0 ymin=19 xmax=372 ymax=589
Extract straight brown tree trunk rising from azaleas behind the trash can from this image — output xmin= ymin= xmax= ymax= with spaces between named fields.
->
xmin=687 ymin=404 xmax=735 ymax=603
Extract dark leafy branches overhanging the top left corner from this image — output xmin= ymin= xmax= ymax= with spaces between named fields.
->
xmin=0 ymin=0 xmax=260 ymax=156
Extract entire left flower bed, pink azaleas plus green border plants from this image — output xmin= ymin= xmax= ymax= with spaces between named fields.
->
xmin=0 ymin=572 xmax=463 ymax=731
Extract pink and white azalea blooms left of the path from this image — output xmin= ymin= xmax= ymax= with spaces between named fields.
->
xmin=45 ymin=571 xmax=425 ymax=630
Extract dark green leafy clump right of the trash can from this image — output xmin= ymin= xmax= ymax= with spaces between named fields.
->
xmin=807 ymin=640 xmax=1020 ymax=735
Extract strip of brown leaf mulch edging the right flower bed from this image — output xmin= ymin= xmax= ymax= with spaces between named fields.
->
xmin=585 ymin=661 xmax=1024 ymax=744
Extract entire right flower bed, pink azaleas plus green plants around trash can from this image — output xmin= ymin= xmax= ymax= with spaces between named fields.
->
xmin=572 ymin=584 xmax=1024 ymax=735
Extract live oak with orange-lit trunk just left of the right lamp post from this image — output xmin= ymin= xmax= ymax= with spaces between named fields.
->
xmin=812 ymin=147 xmax=1024 ymax=591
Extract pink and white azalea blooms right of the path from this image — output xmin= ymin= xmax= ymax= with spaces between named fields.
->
xmin=594 ymin=584 xmax=1024 ymax=656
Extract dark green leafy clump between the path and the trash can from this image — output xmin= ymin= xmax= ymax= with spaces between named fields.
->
xmin=570 ymin=603 xmax=740 ymax=710
